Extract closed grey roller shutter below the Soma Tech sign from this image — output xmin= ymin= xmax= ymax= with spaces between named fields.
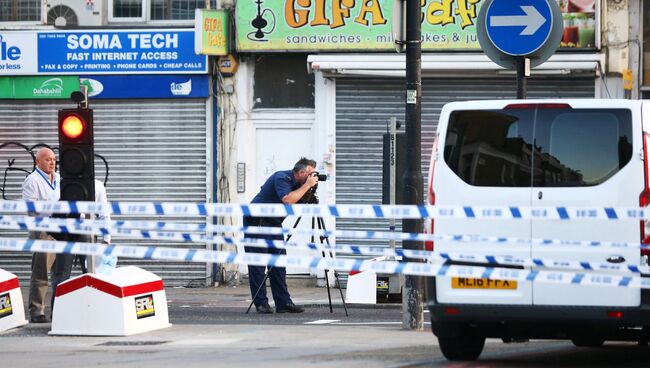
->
xmin=0 ymin=100 xmax=207 ymax=285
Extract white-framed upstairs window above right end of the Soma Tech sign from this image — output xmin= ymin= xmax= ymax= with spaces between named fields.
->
xmin=107 ymin=0 xmax=217 ymax=22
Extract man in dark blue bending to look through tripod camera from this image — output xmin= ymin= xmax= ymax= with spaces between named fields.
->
xmin=244 ymin=157 xmax=318 ymax=314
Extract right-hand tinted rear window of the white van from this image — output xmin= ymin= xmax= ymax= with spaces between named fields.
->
xmin=533 ymin=109 xmax=632 ymax=187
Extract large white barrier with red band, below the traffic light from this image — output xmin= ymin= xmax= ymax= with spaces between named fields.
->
xmin=49 ymin=266 xmax=171 ymax=336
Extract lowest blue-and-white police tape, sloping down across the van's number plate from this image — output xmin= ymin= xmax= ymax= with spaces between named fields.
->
xmin=0 ymin=238 xmax=650 ymax=289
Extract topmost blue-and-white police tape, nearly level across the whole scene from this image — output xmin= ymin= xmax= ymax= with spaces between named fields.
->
xmin=0 ymin=201 xmax=650 ymax=221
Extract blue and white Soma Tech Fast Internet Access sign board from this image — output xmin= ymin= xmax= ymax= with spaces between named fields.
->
xmin=0 ymin=29 xmax=207 ymax=75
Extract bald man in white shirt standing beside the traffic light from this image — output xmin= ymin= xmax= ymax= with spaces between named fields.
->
xmin=22 ymin=148 xmax=61 ymax=323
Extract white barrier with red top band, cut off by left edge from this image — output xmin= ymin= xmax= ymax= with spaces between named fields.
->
xmin=0 ymin=268 xmax=27 ymax=332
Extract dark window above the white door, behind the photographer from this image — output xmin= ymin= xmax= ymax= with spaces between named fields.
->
xmin=253 ymin=54 xmax=314 ymax=108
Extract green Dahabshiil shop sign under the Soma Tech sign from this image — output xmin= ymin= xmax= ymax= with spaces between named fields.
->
xmin=0 ymin=76 xmax=79 ymax=100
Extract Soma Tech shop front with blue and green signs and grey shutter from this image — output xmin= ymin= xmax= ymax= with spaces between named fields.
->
xmin=0 ymin=29 xmax=214 ymax=285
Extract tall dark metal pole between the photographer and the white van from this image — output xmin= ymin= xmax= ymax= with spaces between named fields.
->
xmin=402 ymin=0 xmax=424 ymax=330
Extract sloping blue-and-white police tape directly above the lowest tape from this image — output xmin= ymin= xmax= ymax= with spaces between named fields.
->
xmin=0 ymin=219 xmax=650 ymax=274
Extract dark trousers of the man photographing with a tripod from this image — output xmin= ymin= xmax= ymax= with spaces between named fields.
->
xmin=244 ymin=218 xmax=292 ymax=308
